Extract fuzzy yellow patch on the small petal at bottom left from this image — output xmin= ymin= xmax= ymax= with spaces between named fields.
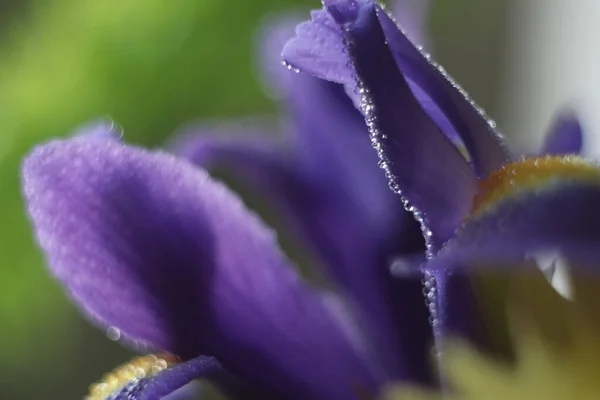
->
xmin=86 ymin=354 xmax=179 ymax=400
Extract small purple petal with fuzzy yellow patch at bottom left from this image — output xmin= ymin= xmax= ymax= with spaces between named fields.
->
xmin=87 ymin=356 xmax=226 ymax=400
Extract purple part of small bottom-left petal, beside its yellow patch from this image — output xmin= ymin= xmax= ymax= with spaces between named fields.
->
xmin=110 ymin=356 xmax=225 ymax=400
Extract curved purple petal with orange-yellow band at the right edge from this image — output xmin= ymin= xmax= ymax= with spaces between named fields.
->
xmin=427 ymin=157 xmax=600 ymax=352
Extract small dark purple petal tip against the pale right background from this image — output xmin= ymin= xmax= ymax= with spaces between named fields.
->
xmin=541 ymin=113 xmax=583 ymax=155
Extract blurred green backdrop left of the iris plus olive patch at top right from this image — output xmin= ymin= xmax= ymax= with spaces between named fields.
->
xmin=0 ymin=0 xmax=506 ymax=399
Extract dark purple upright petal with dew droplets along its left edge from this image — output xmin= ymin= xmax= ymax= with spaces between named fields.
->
xmin=312 ymin=1 xmax=476 ymax=245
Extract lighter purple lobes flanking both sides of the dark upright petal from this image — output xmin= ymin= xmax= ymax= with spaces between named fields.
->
xmin=283 ymin=0 xmax=508 ymax=177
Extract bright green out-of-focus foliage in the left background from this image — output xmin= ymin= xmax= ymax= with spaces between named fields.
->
xmin=0 ymin=0 xmax=309 ymax=398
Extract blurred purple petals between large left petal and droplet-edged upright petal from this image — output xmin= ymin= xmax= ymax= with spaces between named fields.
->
xmin=173 ymin=1 xmax=433 ymax=383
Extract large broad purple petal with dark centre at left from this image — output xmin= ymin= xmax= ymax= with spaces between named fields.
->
xmin=23 ymin=138 xmax=376 ymax=398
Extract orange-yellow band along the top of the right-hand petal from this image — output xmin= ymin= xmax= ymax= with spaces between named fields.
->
xmin=471 ymin=156 xmax=600 ymax=216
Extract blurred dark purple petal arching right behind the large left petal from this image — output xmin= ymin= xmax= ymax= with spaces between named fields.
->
xmin=171 ymin=127 xmax=432 ymax=383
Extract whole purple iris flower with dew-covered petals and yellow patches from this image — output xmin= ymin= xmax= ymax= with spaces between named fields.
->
xmin=23 ymin=0 xmax=600 ymax=399
